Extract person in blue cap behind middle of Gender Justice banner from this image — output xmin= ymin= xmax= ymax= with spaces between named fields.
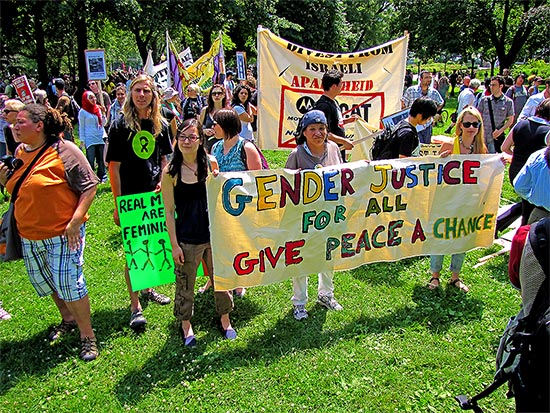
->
xmin=285 ymin=110 xmax=342 ymax=320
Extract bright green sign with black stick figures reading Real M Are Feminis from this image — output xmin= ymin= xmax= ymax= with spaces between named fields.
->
xmin=117 ymin=192 xmax=175 ymax=291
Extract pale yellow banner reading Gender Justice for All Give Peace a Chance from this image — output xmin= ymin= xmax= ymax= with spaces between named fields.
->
xmin=207 ymin=155 xmax=504 ymax=290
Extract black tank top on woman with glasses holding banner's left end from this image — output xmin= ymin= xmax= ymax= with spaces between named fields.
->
xmin=174 ymin=179 xmax=210 ymax=245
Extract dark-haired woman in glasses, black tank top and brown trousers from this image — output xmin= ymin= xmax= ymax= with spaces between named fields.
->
xmin=162 ymin=119 xmax=237 ymax=347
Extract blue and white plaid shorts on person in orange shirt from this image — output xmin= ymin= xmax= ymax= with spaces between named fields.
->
xmin=21 ymin=224 xmax=88 ymax=302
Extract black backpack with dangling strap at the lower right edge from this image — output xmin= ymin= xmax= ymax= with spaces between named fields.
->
xmin=455 ymin=218 xmax=550 ymax=413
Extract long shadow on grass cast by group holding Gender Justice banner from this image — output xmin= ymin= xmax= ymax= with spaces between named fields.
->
xmin=115 ymin=276 xmax=483 ymax=405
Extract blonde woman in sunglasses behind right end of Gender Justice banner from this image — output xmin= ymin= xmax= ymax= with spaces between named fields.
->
xmin=428 ymin=106 xmax=488 ymax=292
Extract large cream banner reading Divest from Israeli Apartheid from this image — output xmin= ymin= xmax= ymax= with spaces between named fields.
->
xmin=258 ymin=28 xmax=408 ymax=149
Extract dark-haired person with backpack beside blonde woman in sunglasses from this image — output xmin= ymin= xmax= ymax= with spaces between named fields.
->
xmin=372 ymin=97 xmax=437 ymax=160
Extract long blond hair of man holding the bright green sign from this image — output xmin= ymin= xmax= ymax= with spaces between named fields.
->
xmin=122 ymin=74 xmax=167 ymax=137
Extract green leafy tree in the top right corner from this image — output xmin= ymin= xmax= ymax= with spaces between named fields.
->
xmin=392 ymin=0 xmax=550 ymax=71
